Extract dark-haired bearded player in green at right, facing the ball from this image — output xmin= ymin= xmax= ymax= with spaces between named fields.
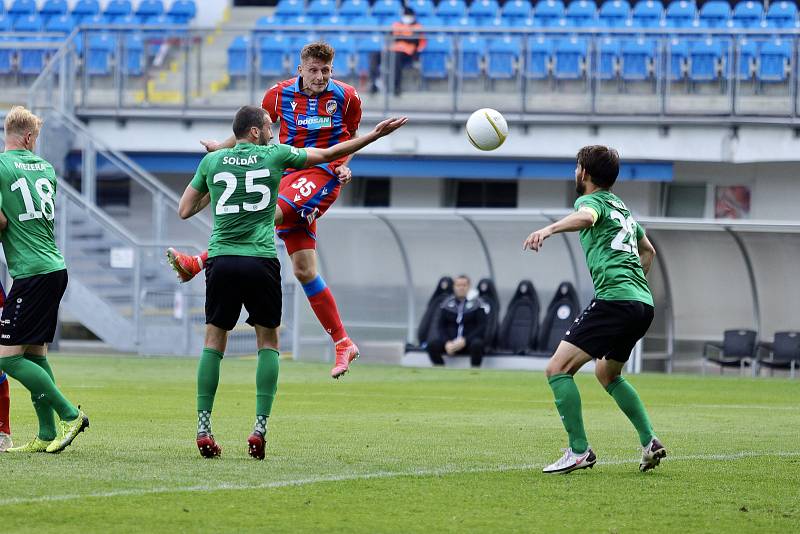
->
xmin=523 ymin=145 xmax=667 ymax=473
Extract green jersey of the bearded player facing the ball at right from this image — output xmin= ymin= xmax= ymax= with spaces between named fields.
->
xmin=575 ymin=190 xmax=653 ymax=306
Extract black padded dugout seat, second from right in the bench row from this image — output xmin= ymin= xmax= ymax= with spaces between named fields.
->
xmin=497 ymin=280 xmax=539 ymax=354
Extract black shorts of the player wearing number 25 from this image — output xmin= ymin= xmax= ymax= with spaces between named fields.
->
xmin=205 ymin=256 xmax=282 ymax=330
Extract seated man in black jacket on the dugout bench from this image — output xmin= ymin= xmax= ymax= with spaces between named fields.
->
xmin=427 ymin=274 xmax=488 ymax=367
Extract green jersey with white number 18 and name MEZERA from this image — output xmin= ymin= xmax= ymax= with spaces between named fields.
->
xmin=0 ymin=150 xmax=66 ymax=279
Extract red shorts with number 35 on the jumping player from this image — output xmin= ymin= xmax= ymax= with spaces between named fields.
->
xmin=276 ymin=167 xmax=341 ymax=254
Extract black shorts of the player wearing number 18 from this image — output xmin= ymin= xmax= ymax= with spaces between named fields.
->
xmin=0 ymin=269 xmax=67 ymax=346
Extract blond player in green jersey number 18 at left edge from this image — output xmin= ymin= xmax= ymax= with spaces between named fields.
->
xmin=0 ymin=106 xmax=89 ymax=452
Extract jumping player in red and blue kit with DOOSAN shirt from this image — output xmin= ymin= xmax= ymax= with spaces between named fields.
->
xmin=167 ymin=42 xmax=368 ymax=378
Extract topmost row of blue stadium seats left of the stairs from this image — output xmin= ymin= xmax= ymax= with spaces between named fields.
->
xmin=0 ymin=0 xmax=197 ymax=27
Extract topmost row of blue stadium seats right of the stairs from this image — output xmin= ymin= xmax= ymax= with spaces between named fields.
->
xmin=264 ymin=0 xmax=798 ymax=29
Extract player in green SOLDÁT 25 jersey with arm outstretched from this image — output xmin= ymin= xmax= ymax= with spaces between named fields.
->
xmin=178 ymin=106 xmax=406 ymax=460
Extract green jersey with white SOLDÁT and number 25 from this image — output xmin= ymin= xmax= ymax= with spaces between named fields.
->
xmin=191 ymin=143 xmax=306 ymax=258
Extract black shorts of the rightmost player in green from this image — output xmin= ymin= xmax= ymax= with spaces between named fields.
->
xmin=564 ymin=299 xmax=654 ymax=363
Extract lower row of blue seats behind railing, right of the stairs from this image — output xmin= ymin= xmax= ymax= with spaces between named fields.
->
xmin=228 ymin=33 xmax=792 ymax=82
